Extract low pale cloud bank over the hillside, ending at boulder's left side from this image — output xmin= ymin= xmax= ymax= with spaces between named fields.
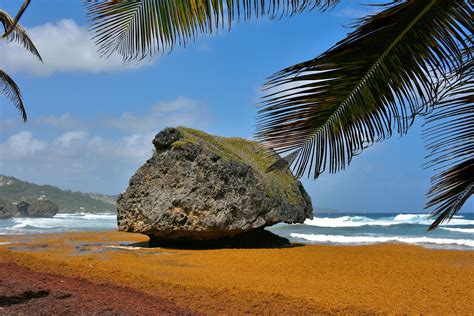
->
xmin=0 ymin=131 xmax=154 ymax=194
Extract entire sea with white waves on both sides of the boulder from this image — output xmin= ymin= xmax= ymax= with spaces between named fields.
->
xmin=0 ymin=213 xmax=474 ymax=250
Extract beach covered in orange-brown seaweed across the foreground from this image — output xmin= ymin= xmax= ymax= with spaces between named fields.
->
xmin=0 ymin=233 xmax=474 ymax=314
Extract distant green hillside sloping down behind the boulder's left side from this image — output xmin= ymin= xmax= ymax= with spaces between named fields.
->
xmin=0 ymin=175 xmax=116 ymax=213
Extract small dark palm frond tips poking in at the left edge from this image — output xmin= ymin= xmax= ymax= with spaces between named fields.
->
xmin=0 ymin=0 xmax=43 ymax=122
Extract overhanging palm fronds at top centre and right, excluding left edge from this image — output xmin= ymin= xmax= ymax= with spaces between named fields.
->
xmin=85 ymin=0 xmax=474 ymax=228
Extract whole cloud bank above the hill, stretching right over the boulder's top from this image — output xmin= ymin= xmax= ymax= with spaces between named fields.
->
xmin=0 ymin=97 xmax=209 ymax=193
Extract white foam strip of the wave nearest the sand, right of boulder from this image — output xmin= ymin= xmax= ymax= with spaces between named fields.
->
xmin=291 ymin=233 xmax=474 ymax=248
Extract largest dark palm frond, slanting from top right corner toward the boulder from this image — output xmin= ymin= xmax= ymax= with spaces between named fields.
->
xmin=256 ymin=0 xmax=472 ymax=178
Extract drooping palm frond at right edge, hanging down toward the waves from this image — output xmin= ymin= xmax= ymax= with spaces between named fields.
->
xmin=424 ymin=59 xmax=474 ymax=230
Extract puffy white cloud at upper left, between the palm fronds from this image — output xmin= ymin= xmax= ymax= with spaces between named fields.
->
xmin=0 ymin=19 xmax=153 ymax=76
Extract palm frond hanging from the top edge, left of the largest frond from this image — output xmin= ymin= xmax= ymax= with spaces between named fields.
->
xmin=84 ymin=0 xmax=340 ymax=61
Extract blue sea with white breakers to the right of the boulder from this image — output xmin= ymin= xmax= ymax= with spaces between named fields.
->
xmin=269 ymin=213 xmax=474 ymax=250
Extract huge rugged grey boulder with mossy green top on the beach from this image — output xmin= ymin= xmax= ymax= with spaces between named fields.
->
xmin=117 ymin=127 xmax=312 ymax=241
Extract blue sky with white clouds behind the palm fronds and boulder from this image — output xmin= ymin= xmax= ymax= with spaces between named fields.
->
xmin=0 ymin=0 xmax=474 ymax=212
